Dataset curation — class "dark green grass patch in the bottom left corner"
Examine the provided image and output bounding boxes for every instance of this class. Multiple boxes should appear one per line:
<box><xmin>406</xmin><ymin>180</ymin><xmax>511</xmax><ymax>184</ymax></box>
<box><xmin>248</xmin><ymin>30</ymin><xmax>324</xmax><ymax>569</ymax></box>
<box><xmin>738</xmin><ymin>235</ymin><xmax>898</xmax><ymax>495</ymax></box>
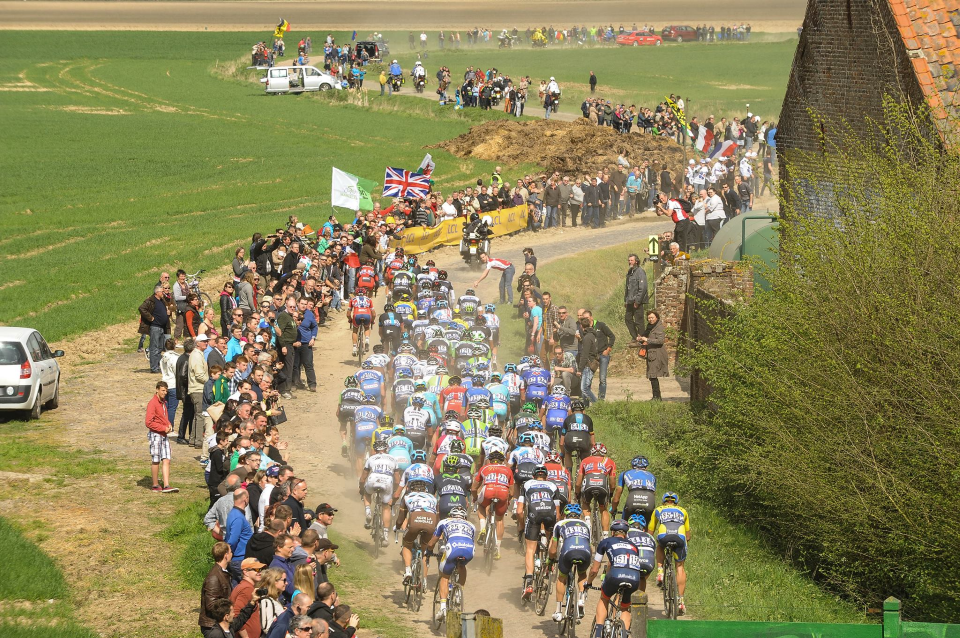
<box><xmin>0</xmin><ymin>517</ymin><xmax>96</xmax><ymax>638</ymax></box>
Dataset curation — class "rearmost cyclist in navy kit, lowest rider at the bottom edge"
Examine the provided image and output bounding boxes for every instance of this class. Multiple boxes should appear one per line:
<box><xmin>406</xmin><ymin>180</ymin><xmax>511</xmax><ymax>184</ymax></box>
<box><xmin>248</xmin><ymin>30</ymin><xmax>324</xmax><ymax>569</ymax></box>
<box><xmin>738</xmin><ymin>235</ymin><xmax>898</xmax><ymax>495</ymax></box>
<box><xmin>587</xmin><ymin>520</ymin><xmax>650</xmax><ymax>638</ymax></box>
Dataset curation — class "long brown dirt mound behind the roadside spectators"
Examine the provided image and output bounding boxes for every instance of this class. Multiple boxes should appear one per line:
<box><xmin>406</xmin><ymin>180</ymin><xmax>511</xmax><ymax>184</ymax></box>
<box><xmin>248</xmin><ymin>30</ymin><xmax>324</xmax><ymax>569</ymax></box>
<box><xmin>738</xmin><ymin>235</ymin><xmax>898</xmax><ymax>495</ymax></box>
<box><xmin>432</xmin><ymin>118</ymin><xmax>684</xmax><ymax>178</ymax></box>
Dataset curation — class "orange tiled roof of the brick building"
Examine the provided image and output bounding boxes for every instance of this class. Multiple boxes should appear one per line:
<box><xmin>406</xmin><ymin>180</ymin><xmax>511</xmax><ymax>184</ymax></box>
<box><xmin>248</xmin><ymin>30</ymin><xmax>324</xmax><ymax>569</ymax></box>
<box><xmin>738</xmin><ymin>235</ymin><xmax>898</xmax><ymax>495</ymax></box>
<box><xmin>887</xmin><ymin>0</ymin><xmax>960</xmax><ymax>134</ymax></box>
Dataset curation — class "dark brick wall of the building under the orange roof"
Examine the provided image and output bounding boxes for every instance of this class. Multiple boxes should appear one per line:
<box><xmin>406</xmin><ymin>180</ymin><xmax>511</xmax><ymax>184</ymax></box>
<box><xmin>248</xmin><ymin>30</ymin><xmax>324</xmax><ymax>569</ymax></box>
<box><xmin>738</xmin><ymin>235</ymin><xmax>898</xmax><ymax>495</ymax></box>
<box><xmin>777</xmin><ymin>0</ymin><xmax>933</xmax><ymax>216</ymax></box>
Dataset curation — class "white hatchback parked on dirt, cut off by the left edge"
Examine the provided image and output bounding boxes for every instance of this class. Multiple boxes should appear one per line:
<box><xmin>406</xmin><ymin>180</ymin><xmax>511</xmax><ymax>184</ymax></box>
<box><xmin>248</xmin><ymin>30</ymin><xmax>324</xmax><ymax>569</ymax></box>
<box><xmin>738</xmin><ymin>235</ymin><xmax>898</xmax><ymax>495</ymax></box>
<box><xmin>0</xmin><ymin>326</ymin><xmax>63</xmax><ymax>419</ymax></box>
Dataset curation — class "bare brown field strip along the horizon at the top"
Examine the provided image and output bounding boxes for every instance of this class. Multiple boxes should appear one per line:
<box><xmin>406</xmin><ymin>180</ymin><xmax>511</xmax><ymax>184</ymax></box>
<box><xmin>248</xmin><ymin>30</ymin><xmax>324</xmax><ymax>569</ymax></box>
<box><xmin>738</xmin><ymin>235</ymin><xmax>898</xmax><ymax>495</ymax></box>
<box><xmin>0</xmin><ymin>0</ymin><xmax>807</xmax><ymax>31</ymax></box>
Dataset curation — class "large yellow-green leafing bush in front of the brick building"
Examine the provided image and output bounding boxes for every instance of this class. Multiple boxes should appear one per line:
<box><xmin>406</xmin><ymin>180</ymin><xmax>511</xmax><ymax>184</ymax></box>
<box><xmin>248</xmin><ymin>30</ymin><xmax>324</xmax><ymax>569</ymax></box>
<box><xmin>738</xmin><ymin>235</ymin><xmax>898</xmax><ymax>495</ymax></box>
<box><xmin>674</xmin><ymin>105</ymin><xmax>960</xmax><ymax>620</ymax></box>
